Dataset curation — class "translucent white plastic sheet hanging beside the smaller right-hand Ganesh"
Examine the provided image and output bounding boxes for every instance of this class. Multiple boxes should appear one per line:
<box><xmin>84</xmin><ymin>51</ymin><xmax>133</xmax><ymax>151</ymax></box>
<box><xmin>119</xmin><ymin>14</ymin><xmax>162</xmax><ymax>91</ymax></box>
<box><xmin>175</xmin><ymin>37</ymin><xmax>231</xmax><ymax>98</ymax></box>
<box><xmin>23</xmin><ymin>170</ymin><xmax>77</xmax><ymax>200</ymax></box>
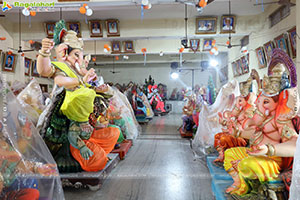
<box><xmin>192</xmin><ymin>80</ymin><xmax>240</xmax><ymax>157</ymax></box>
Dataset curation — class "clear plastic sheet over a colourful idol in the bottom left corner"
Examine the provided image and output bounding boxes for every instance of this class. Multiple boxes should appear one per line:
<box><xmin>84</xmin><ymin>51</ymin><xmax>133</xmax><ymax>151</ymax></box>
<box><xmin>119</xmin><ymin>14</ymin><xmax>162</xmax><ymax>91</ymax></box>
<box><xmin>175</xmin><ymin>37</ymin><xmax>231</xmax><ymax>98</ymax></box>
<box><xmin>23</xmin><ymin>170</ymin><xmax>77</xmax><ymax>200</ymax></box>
<box><xmin>0</xmin><ymin>74</ymin><xmax>64</xmax><ymax>200</ymax></box>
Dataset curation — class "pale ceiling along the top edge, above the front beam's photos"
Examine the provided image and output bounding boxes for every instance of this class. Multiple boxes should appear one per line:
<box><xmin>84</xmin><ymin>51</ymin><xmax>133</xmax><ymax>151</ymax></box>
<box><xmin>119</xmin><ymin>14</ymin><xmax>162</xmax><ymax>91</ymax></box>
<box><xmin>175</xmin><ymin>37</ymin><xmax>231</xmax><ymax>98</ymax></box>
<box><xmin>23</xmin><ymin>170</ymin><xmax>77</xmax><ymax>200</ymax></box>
<box><xmin>0</xmin><ymin>0</ymin><xmax>262</xmax><ymax>22</ymax></box>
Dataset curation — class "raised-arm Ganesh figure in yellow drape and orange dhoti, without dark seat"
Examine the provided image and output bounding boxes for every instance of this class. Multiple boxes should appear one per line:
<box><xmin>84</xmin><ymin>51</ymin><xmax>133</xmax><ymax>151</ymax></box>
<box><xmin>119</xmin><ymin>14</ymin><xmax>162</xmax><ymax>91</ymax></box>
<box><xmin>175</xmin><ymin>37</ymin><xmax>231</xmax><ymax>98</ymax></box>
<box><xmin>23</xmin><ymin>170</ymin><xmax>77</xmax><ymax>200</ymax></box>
<box><xmin>37</xmin><ymin>20</ymin><xmax>120</xmax><ymax>171</ymax></box>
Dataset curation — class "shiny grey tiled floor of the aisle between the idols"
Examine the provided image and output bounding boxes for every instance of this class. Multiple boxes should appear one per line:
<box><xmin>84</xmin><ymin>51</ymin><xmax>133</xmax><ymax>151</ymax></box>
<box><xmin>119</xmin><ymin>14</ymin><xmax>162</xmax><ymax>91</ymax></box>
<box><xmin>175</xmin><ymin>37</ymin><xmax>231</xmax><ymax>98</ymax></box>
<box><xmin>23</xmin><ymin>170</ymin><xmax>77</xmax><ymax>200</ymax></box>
<box><xmin>65</xmin><ymin>115</ymin><xmax>214</xmax><ymax>200</ymax></box>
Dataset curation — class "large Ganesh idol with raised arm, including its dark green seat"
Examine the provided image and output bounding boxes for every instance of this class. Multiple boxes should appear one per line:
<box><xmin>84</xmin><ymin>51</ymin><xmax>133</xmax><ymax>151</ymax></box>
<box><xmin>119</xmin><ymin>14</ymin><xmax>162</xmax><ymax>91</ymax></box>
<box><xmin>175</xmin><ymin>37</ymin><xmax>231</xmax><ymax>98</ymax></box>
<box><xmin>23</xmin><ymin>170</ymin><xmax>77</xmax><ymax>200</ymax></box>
<box><xmin>37</xmin><ymin>20</ymin><xmax>120</xmax><ymax>172</ymax></box>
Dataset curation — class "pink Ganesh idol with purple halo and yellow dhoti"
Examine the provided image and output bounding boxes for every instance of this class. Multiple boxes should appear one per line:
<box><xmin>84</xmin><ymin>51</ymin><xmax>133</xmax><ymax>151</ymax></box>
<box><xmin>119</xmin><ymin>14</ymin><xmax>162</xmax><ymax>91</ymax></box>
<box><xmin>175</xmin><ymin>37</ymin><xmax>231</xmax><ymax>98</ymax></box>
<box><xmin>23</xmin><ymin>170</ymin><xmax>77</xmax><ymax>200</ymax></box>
<box><xmin>224</xmin><ymin>49</ymin><xmax>299</xmax><ymax>195</ymax></box>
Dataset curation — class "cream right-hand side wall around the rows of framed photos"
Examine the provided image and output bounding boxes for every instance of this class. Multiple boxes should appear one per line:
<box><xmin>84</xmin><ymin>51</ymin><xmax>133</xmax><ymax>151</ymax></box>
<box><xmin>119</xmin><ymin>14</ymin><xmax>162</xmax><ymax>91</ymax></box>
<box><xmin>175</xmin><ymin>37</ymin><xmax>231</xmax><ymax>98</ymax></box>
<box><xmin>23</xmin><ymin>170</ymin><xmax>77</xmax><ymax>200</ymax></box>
<box><xmin>228</xmin><ymin>6</ymin><xmax>299</xmax><ymax>82</ymax></box>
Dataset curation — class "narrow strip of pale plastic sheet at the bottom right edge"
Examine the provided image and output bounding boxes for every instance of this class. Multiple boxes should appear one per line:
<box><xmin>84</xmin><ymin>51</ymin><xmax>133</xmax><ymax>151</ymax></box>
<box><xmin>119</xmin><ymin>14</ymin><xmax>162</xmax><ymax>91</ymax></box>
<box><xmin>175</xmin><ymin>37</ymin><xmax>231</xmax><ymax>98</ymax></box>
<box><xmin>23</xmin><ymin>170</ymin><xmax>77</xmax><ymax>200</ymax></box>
<box><xmin>289</xmin><ymin>137</ymin><xmax>300</xmax><ymax>200</ymax></box>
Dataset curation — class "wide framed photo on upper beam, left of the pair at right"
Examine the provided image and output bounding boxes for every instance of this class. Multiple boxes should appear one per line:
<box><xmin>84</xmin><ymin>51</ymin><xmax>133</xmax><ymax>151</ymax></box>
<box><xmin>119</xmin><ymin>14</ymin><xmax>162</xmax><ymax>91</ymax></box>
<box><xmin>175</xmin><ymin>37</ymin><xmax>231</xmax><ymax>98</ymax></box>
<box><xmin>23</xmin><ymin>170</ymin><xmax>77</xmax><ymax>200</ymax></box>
<box><xmin>196</xmin><ymin>17</ymin><xmax>217</xmax><ymax>34</ymax></box>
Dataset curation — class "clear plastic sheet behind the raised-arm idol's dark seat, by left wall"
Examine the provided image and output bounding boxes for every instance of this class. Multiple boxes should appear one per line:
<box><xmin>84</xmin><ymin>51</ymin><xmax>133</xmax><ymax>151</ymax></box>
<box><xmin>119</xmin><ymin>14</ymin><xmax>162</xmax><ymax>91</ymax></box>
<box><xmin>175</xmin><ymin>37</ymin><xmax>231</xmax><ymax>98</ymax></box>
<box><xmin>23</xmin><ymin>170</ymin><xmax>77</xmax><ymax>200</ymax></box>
<box><xmin>17</xmin><ymin>79</ymin><xmax>45</xmax><ymax>125</ymax></box>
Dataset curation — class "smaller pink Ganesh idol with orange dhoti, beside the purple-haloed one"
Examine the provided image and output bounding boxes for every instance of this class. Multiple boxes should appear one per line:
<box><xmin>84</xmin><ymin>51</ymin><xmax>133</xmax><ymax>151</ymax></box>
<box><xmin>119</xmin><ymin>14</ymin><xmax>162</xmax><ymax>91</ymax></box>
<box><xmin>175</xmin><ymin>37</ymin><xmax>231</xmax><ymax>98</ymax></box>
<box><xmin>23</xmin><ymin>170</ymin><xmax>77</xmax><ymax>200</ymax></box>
<box><xmin>214</xmin><ymin>71</ymin><xmax>257</xmax><ymax>163</ymax></box>
